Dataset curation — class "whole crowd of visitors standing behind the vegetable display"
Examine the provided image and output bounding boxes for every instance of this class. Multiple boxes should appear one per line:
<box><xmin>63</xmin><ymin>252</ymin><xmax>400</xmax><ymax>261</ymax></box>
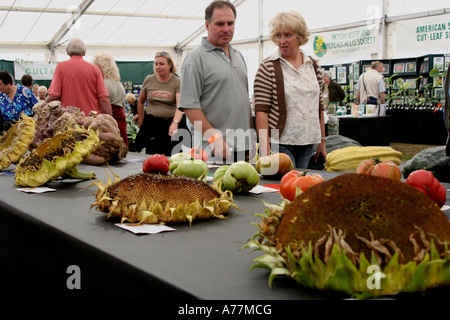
<box><xmin>5</xmin><ymin>0</ymin><xmax>436</xmax><ymax>168</ymax></box>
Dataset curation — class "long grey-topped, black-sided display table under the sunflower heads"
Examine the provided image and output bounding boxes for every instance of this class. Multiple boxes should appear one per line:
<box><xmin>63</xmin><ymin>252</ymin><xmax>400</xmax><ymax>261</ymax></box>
<box><xmin>0</xmin><ymin>153</ymin><xmax>449</xmax><ymax>301</ymax></box>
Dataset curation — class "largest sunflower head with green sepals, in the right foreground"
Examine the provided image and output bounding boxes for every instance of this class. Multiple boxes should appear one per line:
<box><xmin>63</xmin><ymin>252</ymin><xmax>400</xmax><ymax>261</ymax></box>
<box><xmin>245</xmin><ymin>174</ymin><xmax>450</xmax><ymax>298</ymax></box>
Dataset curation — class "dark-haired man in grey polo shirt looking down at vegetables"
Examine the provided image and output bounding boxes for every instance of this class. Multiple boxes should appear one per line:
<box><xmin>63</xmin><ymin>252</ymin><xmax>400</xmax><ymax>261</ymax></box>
<box><xmin>178</xmin><ymin>1</ymin><xmax>251</xmax><ymax>162</ymax></box>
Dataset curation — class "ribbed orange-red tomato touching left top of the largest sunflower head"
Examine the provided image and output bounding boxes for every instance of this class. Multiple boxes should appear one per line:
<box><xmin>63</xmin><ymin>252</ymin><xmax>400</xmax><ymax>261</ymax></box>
<box><xmin>280</xmin><ymin>170</ymin><xmax>325</xmax><ymax>201</ymax></box>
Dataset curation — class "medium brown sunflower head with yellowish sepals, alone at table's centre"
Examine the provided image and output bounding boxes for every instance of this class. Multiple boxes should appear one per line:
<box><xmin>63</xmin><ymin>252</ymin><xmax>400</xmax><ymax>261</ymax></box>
<box><xmin>92</xmin><ymin>172</ymin><xmax>233</xmax><ymax>224</ymax></box>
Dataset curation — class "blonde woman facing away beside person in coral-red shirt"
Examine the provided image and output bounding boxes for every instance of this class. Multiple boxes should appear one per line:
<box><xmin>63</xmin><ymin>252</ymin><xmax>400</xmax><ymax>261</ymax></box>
<box><xmin>92</xmin><ymin>52</ymin><xmax>128</xmax><ymax>147</ymax></box>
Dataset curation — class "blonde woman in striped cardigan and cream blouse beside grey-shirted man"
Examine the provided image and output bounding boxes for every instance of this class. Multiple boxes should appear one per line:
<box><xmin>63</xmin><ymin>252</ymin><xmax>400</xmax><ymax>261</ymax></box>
<box><xmin>254</xmin><ymin>11</ymin><xmax>326</xmax><ymax>168</ymax></box>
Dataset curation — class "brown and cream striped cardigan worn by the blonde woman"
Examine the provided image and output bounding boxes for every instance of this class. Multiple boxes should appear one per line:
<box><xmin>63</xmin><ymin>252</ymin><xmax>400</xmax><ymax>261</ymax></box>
<box><xmin>253</xmin><ymin>57</ymin><xmax>324</xmax><ymax>139</ymax></box>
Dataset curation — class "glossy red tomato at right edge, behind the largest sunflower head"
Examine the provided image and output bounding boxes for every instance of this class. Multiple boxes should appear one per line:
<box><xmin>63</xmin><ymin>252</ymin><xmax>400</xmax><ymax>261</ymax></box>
<box><xmin>405</xmin><ymin>170</ymin><xmax>447</xmax><ymax>207</ymax></box>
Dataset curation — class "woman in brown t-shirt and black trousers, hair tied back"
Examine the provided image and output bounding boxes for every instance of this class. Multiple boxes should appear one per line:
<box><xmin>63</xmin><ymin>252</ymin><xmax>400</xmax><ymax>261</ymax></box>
<box><xmin>136</xmin><ymin>51</ymin><xmax>187</xmax><ymax>156</ymax></box>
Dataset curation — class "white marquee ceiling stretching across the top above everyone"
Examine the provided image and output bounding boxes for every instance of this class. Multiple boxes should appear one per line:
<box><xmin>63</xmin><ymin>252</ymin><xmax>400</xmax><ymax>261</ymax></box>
<box><xmin>0</xmin><ymin>0</ymin><xmax>448</xmax><ymax>55</ymax></box>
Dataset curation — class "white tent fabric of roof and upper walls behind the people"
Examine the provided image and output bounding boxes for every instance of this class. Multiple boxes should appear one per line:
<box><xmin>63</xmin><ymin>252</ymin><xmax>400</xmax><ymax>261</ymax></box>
<box><xmin>0</xmin><ymin>0</ymin><xmax>450</xmax><ymax>93</ymax></box>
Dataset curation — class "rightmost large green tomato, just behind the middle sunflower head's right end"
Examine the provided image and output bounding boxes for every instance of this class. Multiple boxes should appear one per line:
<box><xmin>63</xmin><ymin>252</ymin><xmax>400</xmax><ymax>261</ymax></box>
<box><xmin>223</xmin><ymin>161</ymin><xmax>259</xmax><ymax>193</ymax></box>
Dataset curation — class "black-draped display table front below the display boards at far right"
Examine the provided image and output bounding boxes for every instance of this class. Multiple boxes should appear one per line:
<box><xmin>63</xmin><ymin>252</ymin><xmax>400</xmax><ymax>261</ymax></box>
<box><xmin>386</xmin><ymin>108</ymin><xmax>447</xmax><ymax>145</ymax></box>
